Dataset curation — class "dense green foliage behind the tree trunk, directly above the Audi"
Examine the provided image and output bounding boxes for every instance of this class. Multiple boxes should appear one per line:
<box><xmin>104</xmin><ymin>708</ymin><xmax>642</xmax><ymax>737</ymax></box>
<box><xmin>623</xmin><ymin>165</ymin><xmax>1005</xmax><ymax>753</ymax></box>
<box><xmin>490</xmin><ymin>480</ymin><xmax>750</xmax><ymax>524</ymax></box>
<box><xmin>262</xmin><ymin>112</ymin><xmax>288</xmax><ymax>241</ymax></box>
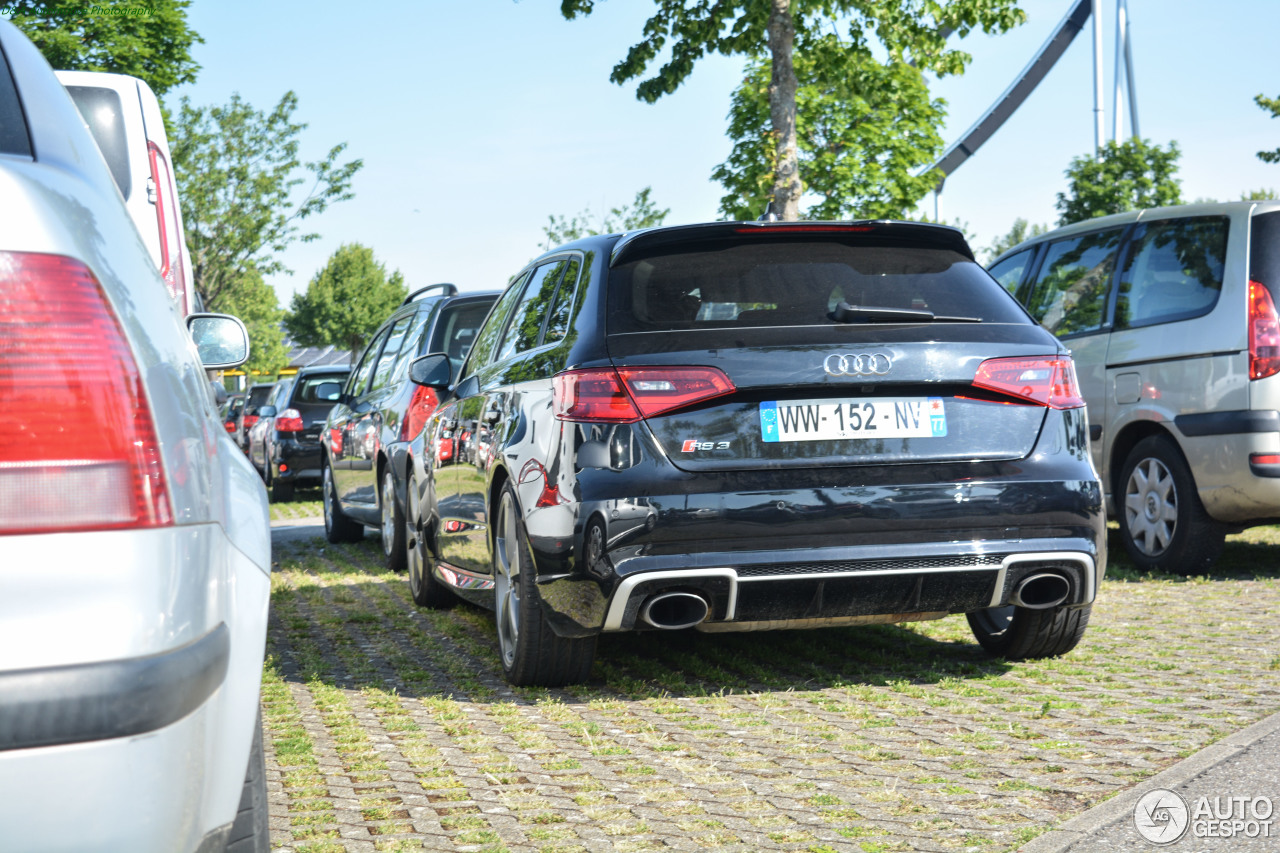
<box><xmin>712</xmin><ymin>43</ymin><xmax>946</xmax><ymax>219</ymax></box>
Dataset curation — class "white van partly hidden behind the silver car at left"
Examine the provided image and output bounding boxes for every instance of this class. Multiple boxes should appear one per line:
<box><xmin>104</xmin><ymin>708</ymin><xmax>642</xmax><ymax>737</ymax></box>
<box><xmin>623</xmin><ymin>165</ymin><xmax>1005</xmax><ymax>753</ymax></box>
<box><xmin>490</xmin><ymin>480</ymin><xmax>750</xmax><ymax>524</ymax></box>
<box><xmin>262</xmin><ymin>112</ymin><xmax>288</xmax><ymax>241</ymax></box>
<box><xmin>56</xmin><ymin>70</ymin><xmax>194</xmax><ymax>315</ymax></box>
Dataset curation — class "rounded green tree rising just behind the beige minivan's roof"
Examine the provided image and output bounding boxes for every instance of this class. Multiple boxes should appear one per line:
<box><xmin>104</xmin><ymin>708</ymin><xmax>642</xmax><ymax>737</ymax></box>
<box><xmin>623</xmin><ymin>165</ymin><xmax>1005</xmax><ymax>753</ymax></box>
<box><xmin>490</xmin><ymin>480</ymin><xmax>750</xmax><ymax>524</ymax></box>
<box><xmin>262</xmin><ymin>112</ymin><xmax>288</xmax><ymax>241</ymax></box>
<box><xmin>1055</xmin><ymin>138</ymin><xmax>1181</xmax><ymax>225</ymax></box>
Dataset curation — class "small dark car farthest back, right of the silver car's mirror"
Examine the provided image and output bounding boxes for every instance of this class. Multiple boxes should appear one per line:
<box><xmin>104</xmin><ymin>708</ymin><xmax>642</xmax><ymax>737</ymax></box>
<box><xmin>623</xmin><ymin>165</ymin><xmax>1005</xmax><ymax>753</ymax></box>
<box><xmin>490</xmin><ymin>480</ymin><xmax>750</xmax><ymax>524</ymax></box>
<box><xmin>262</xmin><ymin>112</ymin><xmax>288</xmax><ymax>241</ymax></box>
<box><xmin>250</xmin><ymin>365</ymin><xmax>351</xmax><ymax>501</ymax></box>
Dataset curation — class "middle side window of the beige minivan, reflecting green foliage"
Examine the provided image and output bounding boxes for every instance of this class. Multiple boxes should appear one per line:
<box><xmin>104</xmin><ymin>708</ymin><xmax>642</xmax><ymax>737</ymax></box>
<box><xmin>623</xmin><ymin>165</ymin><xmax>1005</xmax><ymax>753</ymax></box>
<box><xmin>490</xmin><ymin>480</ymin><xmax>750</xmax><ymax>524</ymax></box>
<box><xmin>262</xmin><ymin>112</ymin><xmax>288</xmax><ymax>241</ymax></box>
<box><xmin>1027</xmin><ymin>228</ymin><xmax>1124</xmax><ymax>336</ymax></box>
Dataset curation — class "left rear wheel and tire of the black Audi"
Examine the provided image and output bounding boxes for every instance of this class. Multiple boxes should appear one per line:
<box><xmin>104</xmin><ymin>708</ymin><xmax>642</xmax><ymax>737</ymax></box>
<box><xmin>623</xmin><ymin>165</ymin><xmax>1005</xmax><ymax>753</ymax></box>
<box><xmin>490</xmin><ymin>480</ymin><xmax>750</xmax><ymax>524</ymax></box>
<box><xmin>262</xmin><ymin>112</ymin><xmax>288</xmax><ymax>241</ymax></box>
<box><xmin>493</xmin><ymin>483</ymin><xmax>595</xmax><ymax>686</ymax></box>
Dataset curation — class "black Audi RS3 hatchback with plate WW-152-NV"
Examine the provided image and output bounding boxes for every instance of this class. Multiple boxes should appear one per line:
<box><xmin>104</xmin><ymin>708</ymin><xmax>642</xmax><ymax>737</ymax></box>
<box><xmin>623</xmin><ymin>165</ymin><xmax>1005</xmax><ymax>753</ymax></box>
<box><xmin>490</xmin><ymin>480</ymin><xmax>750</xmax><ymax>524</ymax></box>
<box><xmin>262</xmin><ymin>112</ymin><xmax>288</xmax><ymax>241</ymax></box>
<box><xmin>404</xmin><ymin>222</ymin><xmax>1106</xmax><ymax>685</ymax></box>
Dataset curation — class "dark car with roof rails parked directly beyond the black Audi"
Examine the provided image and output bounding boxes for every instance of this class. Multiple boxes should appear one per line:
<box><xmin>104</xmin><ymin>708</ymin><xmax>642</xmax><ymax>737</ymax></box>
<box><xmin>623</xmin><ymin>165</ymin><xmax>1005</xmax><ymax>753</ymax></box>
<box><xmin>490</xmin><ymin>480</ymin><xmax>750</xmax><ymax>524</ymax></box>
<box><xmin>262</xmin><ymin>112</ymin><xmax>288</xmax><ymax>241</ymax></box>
<box><xmin>321</xmin><ymin>284</ymin><xmax>498</xmax><ymax>571</ymax></box>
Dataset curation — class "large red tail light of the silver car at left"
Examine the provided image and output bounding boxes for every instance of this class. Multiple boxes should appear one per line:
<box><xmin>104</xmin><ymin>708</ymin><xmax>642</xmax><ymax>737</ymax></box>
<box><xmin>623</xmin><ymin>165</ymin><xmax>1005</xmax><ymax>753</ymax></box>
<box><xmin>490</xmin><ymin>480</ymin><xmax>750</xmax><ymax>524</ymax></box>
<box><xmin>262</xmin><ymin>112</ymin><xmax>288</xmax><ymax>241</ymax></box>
<box><xmin>0</xmin><ymin>252</ymin><xmax>173</xmax><ymax>533</ymax></box>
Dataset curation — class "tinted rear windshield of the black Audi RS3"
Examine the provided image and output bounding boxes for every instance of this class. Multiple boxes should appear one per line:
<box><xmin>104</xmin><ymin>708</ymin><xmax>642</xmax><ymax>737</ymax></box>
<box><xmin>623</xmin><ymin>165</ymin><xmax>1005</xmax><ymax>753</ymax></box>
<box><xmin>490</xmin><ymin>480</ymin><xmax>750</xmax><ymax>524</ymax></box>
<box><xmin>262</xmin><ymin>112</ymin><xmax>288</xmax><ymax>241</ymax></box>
<box><xmin>609</xmin><ymin>240</ymin><xmax>1029</xmax><ymax>334</ymax></box>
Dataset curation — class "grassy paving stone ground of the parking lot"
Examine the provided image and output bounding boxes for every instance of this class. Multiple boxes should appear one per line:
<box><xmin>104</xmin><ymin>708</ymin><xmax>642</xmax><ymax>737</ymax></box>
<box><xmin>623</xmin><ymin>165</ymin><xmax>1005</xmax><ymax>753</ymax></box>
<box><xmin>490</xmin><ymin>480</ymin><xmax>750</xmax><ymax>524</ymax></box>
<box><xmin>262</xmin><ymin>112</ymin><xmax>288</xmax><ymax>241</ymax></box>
<box><xmin>262</xmin><ymin>538</ymin><xmax>1280</xmax><ymax>853</ymax></box>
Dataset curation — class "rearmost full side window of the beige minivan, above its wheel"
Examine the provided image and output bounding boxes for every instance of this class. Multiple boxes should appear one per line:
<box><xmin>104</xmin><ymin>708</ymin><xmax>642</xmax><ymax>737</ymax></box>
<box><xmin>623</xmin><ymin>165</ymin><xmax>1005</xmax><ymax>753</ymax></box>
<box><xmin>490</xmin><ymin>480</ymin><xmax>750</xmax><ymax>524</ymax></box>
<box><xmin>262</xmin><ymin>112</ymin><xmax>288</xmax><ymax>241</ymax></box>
<box><xmin>1116</xmin><ymin>216</ymin><xmax>1231</xmax><ymax>328</ymax></box>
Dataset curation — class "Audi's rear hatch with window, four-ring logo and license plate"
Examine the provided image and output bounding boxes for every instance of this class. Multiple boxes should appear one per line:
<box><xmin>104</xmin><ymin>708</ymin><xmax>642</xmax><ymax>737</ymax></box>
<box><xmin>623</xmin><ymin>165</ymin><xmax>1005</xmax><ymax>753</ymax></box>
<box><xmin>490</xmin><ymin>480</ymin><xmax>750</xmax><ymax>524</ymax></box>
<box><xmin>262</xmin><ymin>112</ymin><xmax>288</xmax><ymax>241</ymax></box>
<box><xmin>607</xmin><ymin>223</ymin><xmax>1062</xmax><ymax>471</ymax></box>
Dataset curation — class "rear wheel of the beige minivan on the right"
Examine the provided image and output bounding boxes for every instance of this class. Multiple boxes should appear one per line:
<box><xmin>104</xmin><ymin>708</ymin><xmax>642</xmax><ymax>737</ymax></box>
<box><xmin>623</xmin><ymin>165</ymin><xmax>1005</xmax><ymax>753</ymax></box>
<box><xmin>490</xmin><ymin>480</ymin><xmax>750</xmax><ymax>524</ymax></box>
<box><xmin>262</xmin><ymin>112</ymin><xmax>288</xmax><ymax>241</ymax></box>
<box><xmin>1116</xmin><ymin>435</ymin><xmax>1226</xmax><ymax>575</ymax></box>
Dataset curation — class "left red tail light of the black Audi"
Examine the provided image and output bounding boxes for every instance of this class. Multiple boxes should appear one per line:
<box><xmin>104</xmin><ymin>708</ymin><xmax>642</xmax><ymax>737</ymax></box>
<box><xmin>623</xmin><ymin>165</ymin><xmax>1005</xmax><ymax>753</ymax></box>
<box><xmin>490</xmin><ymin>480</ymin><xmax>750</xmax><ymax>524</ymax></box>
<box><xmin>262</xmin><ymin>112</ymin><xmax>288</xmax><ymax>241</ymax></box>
<box><xmin>553</xmin><ymin>368</ymin><xmax>736</xmax><ymax>424</ymax></box>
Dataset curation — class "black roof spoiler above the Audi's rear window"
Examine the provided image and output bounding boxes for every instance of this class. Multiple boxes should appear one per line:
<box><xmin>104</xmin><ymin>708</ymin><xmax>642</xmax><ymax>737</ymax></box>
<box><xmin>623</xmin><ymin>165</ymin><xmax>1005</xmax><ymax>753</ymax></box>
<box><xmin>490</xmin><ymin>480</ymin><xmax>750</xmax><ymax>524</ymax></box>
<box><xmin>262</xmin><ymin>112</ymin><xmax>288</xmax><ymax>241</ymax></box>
<box><xmin>609</xmin><ymin>219</ymin><xmax>975</xmax><ymax>266</ymax></box>
